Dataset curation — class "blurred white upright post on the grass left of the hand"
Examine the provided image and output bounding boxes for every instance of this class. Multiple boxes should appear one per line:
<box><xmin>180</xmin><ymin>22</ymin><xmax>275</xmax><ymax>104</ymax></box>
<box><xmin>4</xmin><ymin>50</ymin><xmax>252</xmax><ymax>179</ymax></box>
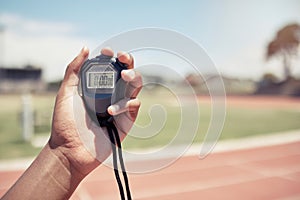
<box><xmin>21</xmin><ymin>94</ymin><xmax>33</xmax><ymax>142</ymax></box>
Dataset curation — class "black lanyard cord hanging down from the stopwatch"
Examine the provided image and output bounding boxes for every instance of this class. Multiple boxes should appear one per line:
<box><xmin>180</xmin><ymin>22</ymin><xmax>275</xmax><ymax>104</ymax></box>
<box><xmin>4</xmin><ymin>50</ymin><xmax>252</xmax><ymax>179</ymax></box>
<box><xmin>100</xmin><ymin>121</ymin><xmax>131</xmax><ymax>200</ymax></box>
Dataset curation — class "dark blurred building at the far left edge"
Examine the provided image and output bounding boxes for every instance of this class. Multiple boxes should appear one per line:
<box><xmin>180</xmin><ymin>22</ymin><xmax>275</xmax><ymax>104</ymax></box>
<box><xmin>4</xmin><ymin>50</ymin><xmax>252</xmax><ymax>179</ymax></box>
<box><xmin>0</xmin><ymin>66</ymin><xmax>46</xmax><ymax>93</ymax></box>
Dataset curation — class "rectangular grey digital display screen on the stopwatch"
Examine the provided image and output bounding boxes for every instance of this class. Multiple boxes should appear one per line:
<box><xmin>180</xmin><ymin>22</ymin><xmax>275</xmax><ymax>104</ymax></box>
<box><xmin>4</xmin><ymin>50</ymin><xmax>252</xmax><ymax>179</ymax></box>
<box><xmin>87</xmin><ymin>71</ymin><xmax>115</xmax><ymax>89</ymax></box>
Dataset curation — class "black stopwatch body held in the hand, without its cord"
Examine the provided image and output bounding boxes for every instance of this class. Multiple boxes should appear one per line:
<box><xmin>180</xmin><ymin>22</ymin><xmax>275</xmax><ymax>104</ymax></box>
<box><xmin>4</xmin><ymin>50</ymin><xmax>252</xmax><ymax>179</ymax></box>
<box><xmin>79</xmin><ymin>55</ymin><xmax>127</xmax><ymax>123</ymax></box>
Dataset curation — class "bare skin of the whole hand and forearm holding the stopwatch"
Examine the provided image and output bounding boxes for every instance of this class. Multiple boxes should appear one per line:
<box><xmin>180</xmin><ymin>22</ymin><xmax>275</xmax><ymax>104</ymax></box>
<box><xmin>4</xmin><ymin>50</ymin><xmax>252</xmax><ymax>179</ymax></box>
<box><xmin>2</xmin><ymin>47</ymin><xmax>142</xmax><ymax>200</ymax></box>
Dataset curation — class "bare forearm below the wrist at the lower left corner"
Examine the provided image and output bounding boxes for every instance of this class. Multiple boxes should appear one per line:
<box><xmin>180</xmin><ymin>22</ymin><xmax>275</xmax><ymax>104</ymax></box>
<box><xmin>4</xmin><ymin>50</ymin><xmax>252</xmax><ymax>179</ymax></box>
<box><xmin>2</xmin><ymin>144</ymin><xmax>84</xmax><ymax>200</ymax></box>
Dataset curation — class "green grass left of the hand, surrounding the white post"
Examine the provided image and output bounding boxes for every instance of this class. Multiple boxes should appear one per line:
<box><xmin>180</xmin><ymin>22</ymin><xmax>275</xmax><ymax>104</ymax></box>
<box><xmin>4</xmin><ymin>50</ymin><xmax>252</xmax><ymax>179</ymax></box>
<box><xmin>0</xmin><ymin>95</ymin><xmax>55</xmax><ymax>159</ymax></box>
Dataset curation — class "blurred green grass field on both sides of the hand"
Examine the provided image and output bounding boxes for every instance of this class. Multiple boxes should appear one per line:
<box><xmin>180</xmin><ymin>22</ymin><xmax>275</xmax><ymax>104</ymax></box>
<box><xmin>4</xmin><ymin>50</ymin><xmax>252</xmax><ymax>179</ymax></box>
<box><xmin>0</xmin><ymin>89</ymin><xmax>300</xmax><ymax>159</ymax></box>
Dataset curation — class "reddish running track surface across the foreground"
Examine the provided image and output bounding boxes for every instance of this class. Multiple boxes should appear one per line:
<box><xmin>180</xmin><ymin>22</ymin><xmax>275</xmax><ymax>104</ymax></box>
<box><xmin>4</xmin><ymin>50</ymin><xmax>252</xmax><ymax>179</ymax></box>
<box><xmin>0</xmin><ymin>142</ymin><xmax>300</xmax><ymax>200</ymax></box>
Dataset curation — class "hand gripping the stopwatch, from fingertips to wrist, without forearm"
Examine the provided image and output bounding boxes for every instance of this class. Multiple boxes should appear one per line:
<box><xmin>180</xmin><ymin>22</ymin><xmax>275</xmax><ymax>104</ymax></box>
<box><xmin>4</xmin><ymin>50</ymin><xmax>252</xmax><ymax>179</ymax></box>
<box><xmin>49</xmin><ymin>48</ymin><xmax>142</xmax><ymax>174</ymax></box>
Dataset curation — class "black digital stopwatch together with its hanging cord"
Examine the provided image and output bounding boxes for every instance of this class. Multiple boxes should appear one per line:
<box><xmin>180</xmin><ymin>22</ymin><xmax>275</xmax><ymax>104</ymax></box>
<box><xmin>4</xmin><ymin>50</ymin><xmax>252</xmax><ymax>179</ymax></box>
<box><xmin>78</xmin><ymin>55</ymin><xmax>131</xmax><ymax>200</ymax></box>
